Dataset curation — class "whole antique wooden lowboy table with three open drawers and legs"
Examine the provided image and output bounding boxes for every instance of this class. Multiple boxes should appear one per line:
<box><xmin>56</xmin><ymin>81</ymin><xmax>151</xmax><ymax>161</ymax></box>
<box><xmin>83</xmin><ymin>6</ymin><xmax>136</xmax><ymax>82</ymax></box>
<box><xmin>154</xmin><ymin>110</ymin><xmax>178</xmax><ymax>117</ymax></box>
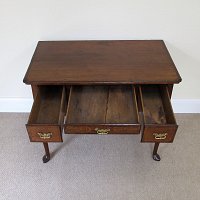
<box><xmin>24</xmin><ymin>40</ymin><xmax>181</xmax><ymax>162</ymax></box>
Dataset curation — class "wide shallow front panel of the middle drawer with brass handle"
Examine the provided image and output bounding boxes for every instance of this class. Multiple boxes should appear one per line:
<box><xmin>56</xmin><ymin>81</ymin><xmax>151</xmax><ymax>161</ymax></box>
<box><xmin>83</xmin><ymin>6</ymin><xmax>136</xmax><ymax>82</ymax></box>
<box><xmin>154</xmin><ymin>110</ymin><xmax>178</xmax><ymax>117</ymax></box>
<box><xmin>65</xmin><ymin>124</ymin><xmax>140</xmax><ymax>135</ymax></box>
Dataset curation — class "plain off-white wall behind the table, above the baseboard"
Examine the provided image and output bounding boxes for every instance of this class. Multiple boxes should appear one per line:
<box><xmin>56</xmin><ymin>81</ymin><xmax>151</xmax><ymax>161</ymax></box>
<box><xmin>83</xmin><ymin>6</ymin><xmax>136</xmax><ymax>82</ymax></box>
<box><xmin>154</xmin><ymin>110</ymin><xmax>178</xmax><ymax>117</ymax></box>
<box><xmin>0</xmin><ymin>0</ymin><xmax>200</xmax><ymax>111</ymax></box>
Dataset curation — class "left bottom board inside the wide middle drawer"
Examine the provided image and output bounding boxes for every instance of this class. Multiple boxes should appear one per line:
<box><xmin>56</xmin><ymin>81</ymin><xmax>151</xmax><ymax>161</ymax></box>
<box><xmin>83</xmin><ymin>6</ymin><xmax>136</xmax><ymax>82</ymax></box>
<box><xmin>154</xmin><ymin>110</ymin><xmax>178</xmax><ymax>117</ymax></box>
<box><xmin>67</xmin><ymin>86</ymin><xmax>108</xmax><ymax>124</ymax></box>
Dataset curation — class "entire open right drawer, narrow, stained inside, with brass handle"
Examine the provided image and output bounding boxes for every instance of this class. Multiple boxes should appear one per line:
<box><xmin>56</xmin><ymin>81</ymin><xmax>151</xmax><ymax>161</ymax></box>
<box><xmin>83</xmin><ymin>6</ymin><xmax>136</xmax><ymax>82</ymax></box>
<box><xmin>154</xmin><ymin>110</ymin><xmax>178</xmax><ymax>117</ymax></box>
<box><xmin>139</xmin><ymin>85</ymin><xmax>178</xmax><ymax>142</ymax></box>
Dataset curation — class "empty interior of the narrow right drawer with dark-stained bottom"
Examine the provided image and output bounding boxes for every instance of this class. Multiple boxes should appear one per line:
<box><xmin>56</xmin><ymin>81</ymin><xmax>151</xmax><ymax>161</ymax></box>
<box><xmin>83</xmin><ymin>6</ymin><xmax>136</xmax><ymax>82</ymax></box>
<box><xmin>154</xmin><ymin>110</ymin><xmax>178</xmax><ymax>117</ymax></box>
<box><xmin>140</xmin><ymin>85</ymin><xmax>176</xmax><ymax>125</ymax></box>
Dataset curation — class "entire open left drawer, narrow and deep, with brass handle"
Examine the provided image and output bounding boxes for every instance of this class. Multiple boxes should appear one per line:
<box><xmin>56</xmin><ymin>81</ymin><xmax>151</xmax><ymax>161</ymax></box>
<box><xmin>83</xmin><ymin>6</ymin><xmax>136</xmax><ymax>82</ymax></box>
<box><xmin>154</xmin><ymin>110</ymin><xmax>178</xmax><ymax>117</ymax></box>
<box><xmin>26</xmin><ymin>86</ymin><xmax>66</xmax><ymax>142</ymax></box>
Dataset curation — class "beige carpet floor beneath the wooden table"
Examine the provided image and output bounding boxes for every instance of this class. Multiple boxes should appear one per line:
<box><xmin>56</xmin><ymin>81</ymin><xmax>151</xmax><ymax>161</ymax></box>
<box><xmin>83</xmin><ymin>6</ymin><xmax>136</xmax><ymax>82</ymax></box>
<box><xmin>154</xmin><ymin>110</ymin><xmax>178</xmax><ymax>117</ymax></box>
<box><xmin>0</xmin><ymin>113</ymin><xmax>200</xmax><ymax>200</ymax></box>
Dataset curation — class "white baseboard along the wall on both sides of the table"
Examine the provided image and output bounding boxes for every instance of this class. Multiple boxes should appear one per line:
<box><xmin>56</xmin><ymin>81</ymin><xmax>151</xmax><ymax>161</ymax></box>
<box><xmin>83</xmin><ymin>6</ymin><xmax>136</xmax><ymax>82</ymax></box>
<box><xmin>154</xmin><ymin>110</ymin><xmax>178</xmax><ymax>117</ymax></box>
<box><xmin>0</xmin><ymin>98</ymin><xmax>200</xmax><ymax>113</ymax></box>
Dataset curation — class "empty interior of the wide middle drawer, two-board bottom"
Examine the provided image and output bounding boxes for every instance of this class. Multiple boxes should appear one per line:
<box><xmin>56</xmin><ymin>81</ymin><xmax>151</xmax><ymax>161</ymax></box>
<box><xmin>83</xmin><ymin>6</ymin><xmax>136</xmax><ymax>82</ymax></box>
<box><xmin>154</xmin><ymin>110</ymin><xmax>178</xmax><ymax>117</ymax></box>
<box><xmin>66</xmin><ymin>85</ymin><xmax>138</xmax><ymax>124</ymax></box>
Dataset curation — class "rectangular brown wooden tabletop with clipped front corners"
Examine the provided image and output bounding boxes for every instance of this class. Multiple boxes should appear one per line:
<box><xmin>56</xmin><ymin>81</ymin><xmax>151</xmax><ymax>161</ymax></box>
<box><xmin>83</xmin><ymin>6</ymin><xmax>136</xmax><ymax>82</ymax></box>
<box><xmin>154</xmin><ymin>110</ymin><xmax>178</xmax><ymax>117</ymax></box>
<box><xmin>24</xmin><ymin>40</ymin><xmax>181</xmax><ymax>85</ymax></box>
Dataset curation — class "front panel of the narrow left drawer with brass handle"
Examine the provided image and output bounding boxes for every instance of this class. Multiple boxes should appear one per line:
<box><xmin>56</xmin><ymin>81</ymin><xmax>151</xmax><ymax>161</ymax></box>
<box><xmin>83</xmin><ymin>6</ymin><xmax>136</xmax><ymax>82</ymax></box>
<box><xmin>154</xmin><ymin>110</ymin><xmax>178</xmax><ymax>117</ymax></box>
<box><xmin>26</xmin><ymin>125</ymin><xmax>62</xmax><ymax>142</ymax></box>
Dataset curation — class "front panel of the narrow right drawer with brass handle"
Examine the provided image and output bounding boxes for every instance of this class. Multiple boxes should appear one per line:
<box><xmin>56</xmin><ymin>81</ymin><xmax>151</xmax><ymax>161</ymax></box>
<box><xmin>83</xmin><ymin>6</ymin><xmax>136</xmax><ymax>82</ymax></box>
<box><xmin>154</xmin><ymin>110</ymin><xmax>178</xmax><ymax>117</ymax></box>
<box><xmin>142</xmin><ymin>125</ymin><xmax>178</xmax><ymax>143</ymax></box>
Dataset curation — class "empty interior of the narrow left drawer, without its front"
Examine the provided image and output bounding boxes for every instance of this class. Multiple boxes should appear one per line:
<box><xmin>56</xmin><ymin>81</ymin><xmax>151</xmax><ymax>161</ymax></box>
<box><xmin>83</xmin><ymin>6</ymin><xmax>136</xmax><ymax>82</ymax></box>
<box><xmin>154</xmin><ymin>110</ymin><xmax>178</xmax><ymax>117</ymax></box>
<box><xmin>28</xmin><ymin>86</ymin><xmax>64</xmax><ymax>124</ymax></box>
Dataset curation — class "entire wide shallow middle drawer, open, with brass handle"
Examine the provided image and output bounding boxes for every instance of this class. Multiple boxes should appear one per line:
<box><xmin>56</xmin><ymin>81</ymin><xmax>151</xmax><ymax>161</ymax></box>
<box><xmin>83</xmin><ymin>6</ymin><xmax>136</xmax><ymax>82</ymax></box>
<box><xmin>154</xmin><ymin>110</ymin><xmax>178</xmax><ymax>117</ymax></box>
<box><xmin>64</xmin><ymin>85</ymin><xmax>140</xmax><ymax>134</ymax></box>
